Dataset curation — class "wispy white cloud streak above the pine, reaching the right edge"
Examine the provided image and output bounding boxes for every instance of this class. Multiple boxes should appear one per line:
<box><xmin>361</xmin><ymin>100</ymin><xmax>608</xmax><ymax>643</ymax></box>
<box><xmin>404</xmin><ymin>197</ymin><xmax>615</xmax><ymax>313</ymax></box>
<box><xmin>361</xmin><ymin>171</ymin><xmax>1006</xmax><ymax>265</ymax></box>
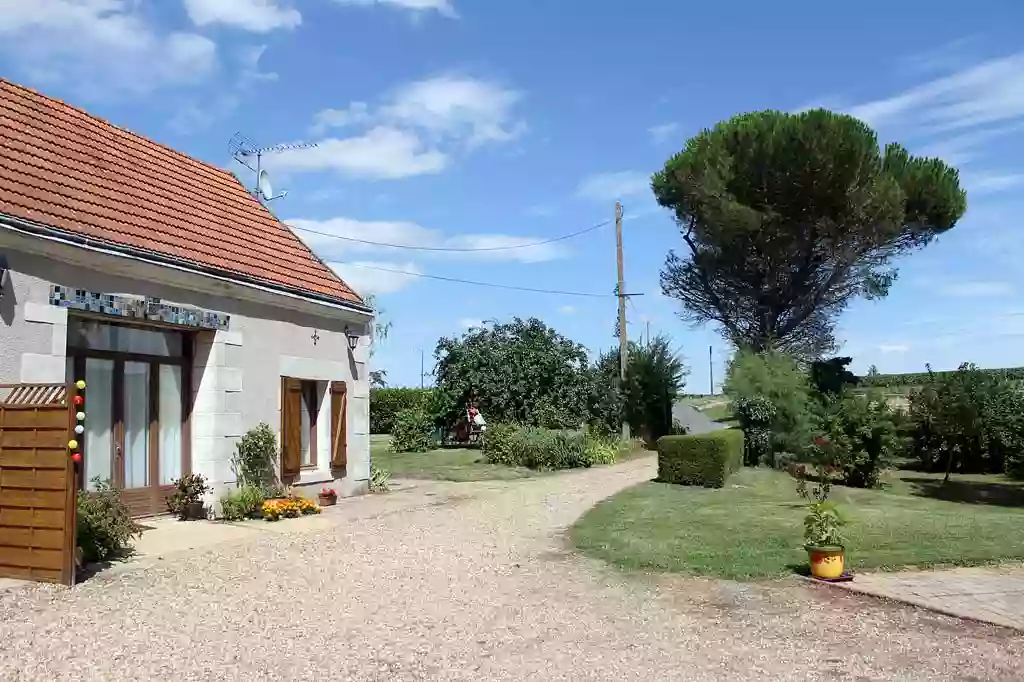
<box><xmin>849</xmin><ymin>52</ymin><xmax>1024</xmax><ymax>131</ymax></box>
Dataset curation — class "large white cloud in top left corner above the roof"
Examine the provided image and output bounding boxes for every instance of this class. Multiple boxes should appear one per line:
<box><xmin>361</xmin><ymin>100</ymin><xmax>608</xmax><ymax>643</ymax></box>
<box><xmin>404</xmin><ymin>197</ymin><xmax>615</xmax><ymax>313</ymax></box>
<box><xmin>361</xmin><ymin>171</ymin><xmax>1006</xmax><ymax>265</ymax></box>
<box><xmin>0</xmin><ymin>0</ymin><xmax>217</xmax><ymax>94</ymax></box>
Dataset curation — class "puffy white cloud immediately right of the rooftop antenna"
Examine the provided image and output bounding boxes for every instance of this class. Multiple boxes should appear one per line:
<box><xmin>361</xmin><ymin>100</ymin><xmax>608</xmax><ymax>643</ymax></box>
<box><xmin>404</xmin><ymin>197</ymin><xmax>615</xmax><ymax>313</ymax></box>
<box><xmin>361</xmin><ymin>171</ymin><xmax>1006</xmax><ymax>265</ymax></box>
<box><xmin>267</xmin><ymin>126</ymin><xmax>447</xmax><ymax>179</ymax></box>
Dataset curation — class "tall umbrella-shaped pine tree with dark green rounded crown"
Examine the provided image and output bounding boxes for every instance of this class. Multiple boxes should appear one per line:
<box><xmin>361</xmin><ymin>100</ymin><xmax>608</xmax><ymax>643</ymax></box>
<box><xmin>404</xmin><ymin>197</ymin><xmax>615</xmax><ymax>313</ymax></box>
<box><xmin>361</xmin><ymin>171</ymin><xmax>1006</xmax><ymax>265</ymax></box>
<box><xmin>652</xmin><ymin>110</ymin><xmax>967</xmax><ymax>358</ymax></box>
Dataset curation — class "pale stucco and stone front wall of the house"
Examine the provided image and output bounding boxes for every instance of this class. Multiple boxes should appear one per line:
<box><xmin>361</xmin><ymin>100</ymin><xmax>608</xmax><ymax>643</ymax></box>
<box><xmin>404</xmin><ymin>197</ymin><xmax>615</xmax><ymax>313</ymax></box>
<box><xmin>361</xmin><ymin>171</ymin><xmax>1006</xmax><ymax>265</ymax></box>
<box><xmin>0</xmin><ymin>233</ymin><xmax>370</xmax><ymax>497</ymax></box>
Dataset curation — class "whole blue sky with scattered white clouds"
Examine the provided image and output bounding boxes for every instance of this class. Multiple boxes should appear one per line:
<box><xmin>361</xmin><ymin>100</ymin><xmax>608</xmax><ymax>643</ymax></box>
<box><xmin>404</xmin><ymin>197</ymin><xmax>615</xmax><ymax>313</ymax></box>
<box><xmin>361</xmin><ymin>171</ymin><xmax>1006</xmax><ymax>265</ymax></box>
<box><xmin>0</xmin><ymin>0</ymin><xmax>1024</xmax><ymax>392</ymax></box>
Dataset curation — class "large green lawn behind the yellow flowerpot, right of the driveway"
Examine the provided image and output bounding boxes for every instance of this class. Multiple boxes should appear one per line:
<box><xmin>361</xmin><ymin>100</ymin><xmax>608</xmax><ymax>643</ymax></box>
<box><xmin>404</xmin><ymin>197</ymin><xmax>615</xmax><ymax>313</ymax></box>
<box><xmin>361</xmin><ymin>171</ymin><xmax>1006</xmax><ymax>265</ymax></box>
<box><xmin>571</xmin><ymin>462</ymin><xmax>1024</xmax><ymax>580</ymax></box>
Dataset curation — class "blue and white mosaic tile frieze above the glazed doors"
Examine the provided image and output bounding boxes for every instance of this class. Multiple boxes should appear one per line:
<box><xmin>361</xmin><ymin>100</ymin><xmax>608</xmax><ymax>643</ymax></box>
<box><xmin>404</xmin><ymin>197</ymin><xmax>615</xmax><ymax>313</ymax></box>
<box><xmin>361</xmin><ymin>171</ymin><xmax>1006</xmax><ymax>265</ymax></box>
<box><xmin>50</xmin><ymin>285</ymin><xmax>230</xmax><ymax>331</ymax></box>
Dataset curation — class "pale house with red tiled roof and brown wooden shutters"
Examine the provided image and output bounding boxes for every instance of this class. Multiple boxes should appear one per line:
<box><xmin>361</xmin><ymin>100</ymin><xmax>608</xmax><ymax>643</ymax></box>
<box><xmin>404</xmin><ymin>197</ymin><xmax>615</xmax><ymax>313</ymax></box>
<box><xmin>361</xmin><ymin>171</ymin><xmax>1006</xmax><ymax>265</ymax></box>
<box><xmin>0</xmin><ymin>80</ymin><xmax>374</xmax><ymax>515</ymax></box>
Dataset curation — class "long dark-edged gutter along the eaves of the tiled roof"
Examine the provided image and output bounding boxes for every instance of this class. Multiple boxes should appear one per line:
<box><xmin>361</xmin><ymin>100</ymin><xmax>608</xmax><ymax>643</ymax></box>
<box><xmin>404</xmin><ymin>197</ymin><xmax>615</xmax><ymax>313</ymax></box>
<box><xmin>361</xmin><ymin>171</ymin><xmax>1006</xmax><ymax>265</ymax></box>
<box><xmin>0</xmin><ymin>213</ymin><xmax>374</xmax><ymax>315</ymax></box>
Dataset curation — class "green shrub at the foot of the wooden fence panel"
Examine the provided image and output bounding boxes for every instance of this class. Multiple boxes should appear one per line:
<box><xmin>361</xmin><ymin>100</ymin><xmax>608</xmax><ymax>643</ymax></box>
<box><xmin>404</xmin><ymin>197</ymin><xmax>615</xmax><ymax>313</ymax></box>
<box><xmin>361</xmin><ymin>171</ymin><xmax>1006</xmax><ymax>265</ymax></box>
<box><xmin>75</xmin><ymin>477</ymin><xmax>142</xmax><ymax>562</ymax></box>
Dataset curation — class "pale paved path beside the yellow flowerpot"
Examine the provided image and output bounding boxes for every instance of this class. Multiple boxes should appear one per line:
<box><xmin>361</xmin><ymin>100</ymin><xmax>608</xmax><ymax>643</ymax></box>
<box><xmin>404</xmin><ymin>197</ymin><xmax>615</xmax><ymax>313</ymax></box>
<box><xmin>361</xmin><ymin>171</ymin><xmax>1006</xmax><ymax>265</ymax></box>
<box><xmin>839</xmin><ymin>564</ymin><xmax>1024</xmax><ymax>631</ymax></box>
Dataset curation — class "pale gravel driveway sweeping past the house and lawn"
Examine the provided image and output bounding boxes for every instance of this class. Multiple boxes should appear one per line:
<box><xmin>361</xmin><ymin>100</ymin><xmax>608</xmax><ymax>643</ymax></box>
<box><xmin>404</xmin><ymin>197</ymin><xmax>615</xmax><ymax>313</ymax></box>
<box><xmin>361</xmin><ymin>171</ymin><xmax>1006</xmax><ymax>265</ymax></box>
<box><xmin>0</xmin><ymin>459</ymin><xmax>1024</xmax><ymax>682</ymax></box>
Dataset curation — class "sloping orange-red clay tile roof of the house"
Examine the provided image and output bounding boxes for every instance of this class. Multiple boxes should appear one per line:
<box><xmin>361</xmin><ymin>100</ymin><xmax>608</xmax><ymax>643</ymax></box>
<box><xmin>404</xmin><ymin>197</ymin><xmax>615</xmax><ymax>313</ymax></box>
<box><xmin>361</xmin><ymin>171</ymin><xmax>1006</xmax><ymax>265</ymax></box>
<box><xmin>0</xmin><ymin>79</ymin><xmax>362</xmax><ymax>304</ymax></box>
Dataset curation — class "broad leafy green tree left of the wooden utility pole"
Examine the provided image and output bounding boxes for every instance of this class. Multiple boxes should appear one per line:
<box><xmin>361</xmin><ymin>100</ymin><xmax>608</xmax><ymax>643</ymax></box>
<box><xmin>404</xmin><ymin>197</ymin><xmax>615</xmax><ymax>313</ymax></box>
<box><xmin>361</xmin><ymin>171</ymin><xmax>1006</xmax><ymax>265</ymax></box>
<box><xmin>434</xmin><ymin>317</ymin><xmax>593</xmax><ymax>428</ymax></box>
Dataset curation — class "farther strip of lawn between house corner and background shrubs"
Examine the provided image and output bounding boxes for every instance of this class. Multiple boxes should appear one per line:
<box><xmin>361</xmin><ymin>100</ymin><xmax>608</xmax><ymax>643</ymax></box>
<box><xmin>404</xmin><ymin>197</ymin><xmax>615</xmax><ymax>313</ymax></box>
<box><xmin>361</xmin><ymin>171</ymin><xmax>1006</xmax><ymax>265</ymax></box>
<box><xmin>370</xmin><ymin>435</ymin><xmax>652</xmax><ymax>482</ymax></box>
